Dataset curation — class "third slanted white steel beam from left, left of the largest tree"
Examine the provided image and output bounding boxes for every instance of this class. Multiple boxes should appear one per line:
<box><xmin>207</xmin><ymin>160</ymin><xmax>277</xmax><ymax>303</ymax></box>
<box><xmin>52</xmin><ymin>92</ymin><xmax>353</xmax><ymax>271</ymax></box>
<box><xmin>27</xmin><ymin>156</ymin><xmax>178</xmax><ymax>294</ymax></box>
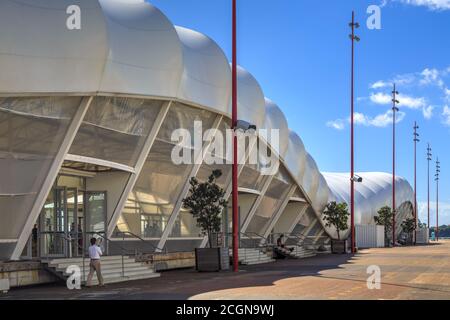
<box><xmin>156</xmin><ymin>115</ymin><xmax>223</xmax><ymax>252</ymax></box>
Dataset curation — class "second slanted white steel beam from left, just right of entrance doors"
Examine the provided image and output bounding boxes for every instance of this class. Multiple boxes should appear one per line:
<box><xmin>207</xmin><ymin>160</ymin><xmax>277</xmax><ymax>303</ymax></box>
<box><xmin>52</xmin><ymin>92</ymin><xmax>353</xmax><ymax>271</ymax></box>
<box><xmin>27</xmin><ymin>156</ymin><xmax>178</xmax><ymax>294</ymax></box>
<box><xmin>107</xmin><ymin>101</ymin><xmax>172</xmax><ymax>238</ymax></box>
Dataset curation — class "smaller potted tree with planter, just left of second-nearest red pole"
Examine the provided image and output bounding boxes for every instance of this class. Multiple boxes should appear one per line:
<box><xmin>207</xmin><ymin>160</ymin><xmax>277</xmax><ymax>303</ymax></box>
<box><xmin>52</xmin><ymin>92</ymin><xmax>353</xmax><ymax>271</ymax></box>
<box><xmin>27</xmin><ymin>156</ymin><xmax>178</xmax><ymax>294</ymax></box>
<box><xmin>323</xmin><ymin>201</ymin><xmax>350</xmax><ymax>253</ymax></box>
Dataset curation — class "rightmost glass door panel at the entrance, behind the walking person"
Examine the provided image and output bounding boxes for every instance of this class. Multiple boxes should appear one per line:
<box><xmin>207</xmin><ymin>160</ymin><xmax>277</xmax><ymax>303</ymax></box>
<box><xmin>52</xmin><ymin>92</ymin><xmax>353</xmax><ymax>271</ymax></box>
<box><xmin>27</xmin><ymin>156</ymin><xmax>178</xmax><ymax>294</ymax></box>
<box><xmin>85</xmin><ymin>191</ymin><xmax>108</xmax><ymax>254</ymax></box>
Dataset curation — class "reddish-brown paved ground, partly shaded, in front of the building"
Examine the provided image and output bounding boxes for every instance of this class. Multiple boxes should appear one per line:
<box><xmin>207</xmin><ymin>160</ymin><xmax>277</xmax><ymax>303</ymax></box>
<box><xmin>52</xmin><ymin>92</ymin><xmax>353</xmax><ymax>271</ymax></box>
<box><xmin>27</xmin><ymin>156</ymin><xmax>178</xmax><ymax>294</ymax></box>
<box><xmin>0</xmin><ymin>240</ymin><xmax>450</xmax><ymax>300</ymax></box>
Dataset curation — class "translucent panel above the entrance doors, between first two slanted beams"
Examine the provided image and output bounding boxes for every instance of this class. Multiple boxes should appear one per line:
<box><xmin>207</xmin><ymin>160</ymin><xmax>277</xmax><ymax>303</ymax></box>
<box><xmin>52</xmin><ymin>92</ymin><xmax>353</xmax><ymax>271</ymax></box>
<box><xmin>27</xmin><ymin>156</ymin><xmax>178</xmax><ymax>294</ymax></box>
<box><xmin>69</xmin><ymin>97</ymin><xmax>164</xmax><ymax>167</ymax></box>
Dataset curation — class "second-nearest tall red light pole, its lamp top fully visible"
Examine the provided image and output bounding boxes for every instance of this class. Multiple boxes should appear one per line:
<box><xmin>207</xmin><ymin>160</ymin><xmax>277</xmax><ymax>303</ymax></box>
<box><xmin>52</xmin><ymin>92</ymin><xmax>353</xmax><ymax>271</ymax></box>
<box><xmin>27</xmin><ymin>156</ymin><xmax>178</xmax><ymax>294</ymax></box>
<box><xmin>349</xmin><ymin>11</ymin><xmax>360</xmax><ymax>253</ymax></box>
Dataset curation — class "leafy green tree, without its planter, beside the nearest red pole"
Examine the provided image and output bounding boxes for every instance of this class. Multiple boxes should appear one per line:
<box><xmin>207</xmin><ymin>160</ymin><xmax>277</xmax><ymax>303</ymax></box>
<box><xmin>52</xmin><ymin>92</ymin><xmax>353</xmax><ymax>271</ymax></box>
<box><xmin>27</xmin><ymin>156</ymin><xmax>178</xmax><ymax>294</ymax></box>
<box><xmin>183</xmin><ymin>170</ymin><xmax>228</xmax><ymax>248</ymax></box>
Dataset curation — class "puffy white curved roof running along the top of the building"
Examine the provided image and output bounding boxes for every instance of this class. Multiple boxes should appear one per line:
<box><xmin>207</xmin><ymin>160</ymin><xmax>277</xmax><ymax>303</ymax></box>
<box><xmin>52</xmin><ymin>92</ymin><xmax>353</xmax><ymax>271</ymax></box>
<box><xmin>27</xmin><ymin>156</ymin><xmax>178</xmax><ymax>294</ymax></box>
<box><xmin>0</xmin><ymin>0</ymin><xmax>411</xmax><ymax>242</ymax></box>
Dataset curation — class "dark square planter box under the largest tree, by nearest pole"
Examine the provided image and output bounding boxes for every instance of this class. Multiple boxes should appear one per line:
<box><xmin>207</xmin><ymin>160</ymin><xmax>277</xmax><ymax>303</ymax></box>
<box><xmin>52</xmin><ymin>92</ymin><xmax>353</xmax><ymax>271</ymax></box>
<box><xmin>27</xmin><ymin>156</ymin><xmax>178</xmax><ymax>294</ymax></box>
<box><xmin>195</xmin><ymin>248</ymin><xmax>230</xmax><ymax>272</ymax></box>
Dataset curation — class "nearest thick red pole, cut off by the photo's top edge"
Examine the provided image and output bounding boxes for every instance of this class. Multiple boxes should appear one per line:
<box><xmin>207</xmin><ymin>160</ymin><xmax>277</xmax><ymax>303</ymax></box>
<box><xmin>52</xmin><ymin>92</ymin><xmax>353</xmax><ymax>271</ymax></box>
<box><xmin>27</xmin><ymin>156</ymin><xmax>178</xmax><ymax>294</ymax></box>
<box><xmin>231</xmin><ymin>0</ymin><xmax>240</xmax><ymax>272</ymax></box>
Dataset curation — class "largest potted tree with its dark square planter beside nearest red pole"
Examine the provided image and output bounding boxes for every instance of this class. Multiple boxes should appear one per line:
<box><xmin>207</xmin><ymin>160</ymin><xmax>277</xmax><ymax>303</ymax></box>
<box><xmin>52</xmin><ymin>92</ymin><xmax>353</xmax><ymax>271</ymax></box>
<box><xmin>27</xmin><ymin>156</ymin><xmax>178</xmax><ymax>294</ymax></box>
<box><xmin>183</xmin><ymin>170</ymin><xmax>230</xmax><ymax>271</ymax></box>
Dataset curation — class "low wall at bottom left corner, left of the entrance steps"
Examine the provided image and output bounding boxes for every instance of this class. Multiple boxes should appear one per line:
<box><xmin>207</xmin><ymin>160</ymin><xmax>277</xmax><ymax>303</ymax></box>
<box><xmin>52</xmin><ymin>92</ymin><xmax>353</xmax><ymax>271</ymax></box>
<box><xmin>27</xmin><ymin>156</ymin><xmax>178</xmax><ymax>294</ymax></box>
<box><xmin>0</xmin><ymin>261</ymin><xmax>58</xmax><ymax>288</ymax></box>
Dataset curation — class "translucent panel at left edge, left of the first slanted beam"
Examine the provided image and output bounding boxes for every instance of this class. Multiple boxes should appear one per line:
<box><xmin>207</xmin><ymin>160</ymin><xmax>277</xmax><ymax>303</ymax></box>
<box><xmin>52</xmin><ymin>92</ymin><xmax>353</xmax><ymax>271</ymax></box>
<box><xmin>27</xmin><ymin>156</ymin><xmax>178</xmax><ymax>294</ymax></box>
<box><xmin>0</xmin><ymin>97</ymin><xmax>82</xmax><ymax>239</ymax></box>
